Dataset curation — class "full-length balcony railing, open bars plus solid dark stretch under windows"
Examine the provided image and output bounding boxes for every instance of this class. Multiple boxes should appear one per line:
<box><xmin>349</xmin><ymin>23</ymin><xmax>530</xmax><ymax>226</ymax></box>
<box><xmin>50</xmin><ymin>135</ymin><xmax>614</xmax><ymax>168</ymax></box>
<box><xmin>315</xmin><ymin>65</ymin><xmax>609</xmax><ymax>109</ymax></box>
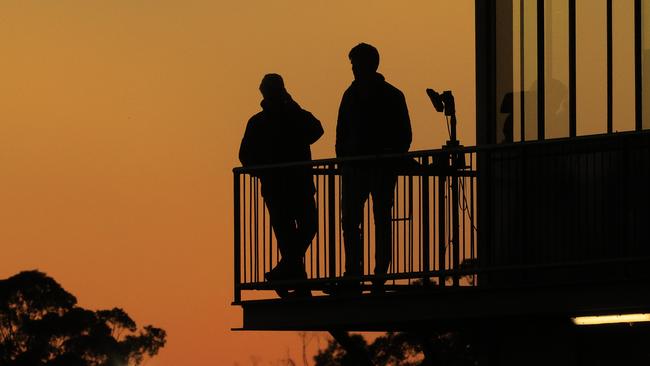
<box><xmin>234</xmin><ymin>131</ymin><xmax>650</xmax><ymax>301</ymax></box>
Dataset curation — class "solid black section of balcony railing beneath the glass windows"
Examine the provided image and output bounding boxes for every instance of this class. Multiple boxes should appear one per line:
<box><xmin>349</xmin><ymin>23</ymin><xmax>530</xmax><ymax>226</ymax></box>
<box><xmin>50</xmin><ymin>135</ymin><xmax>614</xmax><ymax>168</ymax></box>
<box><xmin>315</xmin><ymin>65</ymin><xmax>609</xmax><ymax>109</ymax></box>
<box><xmin>478</xmin><ymin>131</ymin><xmax>650</xmax><ymax>286</ymax></box>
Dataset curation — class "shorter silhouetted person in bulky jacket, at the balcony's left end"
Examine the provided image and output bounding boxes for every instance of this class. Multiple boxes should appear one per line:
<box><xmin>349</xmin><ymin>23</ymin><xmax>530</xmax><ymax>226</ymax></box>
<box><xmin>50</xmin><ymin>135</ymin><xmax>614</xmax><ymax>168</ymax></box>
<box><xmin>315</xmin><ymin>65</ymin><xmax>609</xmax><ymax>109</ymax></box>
<box><xmin>239</xmin><ymin>74</ymin><xmax>323</xmax><ymax>298</ymax></box>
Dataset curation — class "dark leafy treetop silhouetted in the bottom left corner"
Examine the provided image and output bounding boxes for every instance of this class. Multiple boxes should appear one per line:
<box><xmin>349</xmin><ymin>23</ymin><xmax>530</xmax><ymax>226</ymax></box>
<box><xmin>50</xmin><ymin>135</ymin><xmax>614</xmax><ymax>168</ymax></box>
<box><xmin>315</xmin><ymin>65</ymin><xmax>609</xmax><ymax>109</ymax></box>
<box><xmin>0</xmin><ymin>271</ymin><xmax>166</xmax><ymax>366</ymax></box>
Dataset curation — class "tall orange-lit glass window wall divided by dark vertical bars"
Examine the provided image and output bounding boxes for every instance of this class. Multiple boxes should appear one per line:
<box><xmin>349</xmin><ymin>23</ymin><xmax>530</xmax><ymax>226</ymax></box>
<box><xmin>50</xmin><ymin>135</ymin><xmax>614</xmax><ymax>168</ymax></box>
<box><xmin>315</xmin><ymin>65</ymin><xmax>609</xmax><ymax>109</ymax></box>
<box><xmin>494</xmin><ymin>0</ymin><xmax>650</xmax><ymax>142</ymax></box>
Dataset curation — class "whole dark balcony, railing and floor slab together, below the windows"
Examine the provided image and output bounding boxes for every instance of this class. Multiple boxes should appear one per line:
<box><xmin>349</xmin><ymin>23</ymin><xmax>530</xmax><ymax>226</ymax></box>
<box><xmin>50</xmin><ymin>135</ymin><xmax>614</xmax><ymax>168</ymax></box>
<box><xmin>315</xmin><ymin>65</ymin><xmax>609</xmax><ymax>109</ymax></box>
<box><xmin>234</xmin><ymin>132</ymin><xmax>650</xmax><ymax>331</ymax></box>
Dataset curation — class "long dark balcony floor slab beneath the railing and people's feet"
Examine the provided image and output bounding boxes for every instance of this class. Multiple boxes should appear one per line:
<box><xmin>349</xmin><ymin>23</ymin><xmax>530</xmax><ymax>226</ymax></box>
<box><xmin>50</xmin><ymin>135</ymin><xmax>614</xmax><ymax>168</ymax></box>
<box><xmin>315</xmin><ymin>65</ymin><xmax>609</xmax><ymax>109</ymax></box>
<box><xmin>234</xmin><ymin>280</ymin><xmax>650</xmax><ymax>331</ymax></box>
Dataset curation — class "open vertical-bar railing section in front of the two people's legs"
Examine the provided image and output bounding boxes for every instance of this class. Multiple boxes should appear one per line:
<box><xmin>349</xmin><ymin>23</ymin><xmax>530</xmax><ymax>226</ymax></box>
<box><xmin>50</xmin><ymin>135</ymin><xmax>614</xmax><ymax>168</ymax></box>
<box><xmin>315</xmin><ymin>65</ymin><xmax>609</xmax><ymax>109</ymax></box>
<box><xmin>233</xmin><ymin>148</ymin><xmax>477</xmax><ymax>301</ymax></box>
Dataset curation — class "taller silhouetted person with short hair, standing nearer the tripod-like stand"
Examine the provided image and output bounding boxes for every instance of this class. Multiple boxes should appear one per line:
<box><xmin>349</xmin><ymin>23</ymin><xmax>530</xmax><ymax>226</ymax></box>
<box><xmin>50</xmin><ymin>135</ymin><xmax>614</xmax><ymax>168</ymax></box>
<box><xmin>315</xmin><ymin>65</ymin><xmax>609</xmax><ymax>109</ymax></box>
<box><xmin>336</xmin><ymin>43</ymin><xmax>411</xmax><ymax>290</ymax></box>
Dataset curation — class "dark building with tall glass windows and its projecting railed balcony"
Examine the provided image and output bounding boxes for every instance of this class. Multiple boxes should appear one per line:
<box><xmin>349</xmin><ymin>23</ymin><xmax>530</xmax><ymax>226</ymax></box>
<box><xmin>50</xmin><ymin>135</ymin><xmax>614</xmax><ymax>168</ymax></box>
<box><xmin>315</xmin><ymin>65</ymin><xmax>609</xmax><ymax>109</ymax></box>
<box><xmin>234</xmin><ymin>0</ymin><xmax>650</xmax><ymax>365</ymax></box>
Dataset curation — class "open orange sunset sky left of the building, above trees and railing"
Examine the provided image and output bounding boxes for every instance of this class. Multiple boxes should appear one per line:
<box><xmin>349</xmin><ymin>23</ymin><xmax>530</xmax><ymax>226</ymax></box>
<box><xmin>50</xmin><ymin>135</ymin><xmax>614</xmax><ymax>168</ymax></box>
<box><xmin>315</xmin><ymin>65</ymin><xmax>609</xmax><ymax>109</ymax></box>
<box><xmin>0</xmin><ymin>0</ymin><xmax>475</xmax><ymax>366</ymax></box>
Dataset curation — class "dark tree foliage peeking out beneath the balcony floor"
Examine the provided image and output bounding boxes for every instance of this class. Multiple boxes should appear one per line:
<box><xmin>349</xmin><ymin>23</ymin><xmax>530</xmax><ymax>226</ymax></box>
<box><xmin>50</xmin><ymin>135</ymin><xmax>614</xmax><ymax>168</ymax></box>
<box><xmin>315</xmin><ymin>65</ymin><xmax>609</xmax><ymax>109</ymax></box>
<box><xmin>314</xmin><ymin>332</ymin><xmax>477</xmax><ymax>366</ymax></box>
